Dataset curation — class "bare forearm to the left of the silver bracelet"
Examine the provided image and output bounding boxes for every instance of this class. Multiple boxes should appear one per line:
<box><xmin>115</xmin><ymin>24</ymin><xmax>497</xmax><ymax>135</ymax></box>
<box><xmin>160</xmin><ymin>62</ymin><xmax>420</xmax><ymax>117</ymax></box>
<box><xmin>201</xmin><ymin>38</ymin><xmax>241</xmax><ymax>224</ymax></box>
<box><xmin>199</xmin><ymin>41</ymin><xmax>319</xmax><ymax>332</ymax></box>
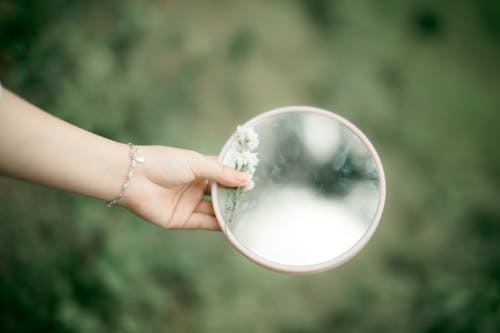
<box><xmin>0</xmin><ymin>89</ymin><xmax>130</xmax><ymax>200</ymax></box>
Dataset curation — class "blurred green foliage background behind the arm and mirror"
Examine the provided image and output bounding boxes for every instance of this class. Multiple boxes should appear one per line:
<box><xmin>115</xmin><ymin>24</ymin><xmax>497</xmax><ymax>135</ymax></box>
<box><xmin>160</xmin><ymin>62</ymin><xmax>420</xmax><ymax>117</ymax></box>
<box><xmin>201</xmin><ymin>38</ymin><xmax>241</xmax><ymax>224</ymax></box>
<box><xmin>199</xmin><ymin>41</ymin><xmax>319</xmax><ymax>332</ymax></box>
<box><xmin>0</xmin><ymin>0</ymin><xmax>500</xmax><ymax>333</ymax></box>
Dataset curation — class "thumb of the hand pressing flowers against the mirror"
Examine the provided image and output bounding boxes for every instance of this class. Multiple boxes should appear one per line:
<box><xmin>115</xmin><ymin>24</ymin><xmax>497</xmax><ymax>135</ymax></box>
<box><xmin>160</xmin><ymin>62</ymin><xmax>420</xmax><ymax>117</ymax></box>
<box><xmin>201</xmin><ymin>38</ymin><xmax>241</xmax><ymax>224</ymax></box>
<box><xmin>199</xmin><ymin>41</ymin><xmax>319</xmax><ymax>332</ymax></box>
<box><xmin>191</xmin><ymin>154</ymin><xmax>250</xmax><ymax>187</ymax></box>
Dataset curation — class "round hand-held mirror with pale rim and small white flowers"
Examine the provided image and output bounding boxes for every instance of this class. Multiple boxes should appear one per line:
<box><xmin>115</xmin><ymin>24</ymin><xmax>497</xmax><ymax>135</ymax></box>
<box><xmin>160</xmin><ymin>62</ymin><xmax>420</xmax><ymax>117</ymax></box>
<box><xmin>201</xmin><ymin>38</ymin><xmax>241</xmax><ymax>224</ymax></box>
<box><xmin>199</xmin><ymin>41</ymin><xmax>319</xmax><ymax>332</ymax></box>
<box><xmin>212</xmin><ymin>106</ymin><xmax>385</xmax><ymax>273</ymax></box>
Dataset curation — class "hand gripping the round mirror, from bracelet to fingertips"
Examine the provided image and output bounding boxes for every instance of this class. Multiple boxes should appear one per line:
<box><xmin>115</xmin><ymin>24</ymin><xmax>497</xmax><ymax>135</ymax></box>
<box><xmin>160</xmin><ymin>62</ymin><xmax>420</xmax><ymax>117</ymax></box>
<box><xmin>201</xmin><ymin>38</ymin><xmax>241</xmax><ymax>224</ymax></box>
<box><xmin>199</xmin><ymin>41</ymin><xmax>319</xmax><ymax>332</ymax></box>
<box><xmin>120</xmin><ymin>146</ymin><xmax>249</xmax><ymax>230</ymax></box>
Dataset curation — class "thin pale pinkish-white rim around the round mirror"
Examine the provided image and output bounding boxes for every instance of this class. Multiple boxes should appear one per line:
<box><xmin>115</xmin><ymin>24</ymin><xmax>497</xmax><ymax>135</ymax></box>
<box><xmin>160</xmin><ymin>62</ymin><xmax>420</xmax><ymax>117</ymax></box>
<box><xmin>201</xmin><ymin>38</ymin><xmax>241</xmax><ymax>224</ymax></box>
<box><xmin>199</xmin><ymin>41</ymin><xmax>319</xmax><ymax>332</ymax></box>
<box><xmin>212</xmin><ymin>106</ymin><xmax>386</xmax><ymax>274</ymax></box>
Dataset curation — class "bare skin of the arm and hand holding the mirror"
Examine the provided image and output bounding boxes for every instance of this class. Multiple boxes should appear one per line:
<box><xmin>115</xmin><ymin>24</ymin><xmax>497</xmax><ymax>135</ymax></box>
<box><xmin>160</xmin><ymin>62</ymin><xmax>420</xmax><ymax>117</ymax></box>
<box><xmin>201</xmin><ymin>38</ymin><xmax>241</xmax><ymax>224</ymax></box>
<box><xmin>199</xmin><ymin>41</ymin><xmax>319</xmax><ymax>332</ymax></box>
<box><xmin>0</xmin><ymin>87</ymin><xmax>249</xmax><ymax>230</ymax></box>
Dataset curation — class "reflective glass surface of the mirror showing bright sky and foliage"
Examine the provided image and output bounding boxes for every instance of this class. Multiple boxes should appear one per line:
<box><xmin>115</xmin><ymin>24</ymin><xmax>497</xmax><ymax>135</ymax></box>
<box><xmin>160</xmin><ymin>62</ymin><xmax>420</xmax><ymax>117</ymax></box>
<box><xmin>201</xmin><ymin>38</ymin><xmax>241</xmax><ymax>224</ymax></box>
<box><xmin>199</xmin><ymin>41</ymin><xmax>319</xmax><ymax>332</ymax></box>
<box><xmin>217</xmin><ymin>112</ymin><xmax>379</xmax><ymax>266</ymax></box>
